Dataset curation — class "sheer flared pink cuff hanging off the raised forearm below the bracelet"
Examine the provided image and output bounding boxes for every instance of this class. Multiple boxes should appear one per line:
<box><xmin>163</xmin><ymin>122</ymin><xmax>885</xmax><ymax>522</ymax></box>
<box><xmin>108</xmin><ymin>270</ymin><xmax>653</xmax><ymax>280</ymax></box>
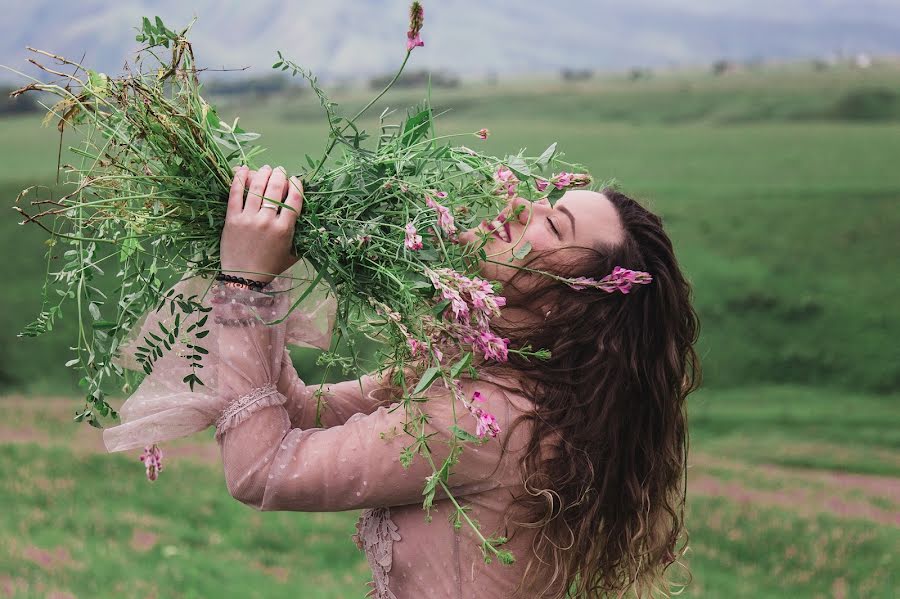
<box><xmin>103</xmin><ymin>261</ymin><xmax>335</xmax><ymax>452</ymax></box>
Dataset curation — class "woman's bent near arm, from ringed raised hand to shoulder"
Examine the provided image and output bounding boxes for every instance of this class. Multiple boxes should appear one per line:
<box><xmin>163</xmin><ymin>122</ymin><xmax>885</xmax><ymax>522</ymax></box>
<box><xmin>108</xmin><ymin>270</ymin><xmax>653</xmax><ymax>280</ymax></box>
<box><xmin>213</xmin><ymin>169</ymin><xmax>509</xmax><ymax>511</ymax></box>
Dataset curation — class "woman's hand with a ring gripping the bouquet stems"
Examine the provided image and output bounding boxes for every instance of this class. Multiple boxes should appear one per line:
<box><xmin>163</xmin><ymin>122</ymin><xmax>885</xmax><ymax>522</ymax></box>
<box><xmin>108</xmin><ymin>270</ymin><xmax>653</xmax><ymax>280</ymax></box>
<box><xmin>219</xmin><ymin>164</ymin><xmax>303</xmax><ymax>283</ymax></box>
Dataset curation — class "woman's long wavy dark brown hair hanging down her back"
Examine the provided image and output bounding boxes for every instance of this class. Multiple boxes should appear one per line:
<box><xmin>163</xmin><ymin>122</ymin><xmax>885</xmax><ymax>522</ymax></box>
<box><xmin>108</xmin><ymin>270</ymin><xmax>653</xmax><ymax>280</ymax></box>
<box><xmin>486</xmin><ymin>189</ymin><xmax>700</xmax><ymax>599</ymax></box>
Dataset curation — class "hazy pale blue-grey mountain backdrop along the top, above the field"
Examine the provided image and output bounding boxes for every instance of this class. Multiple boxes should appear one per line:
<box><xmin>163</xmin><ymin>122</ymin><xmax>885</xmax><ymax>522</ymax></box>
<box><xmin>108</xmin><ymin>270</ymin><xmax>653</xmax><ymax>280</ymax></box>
<box><xmin>0</xmin><ymin>0</ymin><xmax>900</xmax><ymax>81</ymax></box>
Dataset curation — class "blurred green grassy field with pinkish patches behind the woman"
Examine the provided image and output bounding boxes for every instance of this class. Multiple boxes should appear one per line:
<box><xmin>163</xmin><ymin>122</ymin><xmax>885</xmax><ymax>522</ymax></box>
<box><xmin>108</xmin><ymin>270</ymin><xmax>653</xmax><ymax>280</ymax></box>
<box><xmin>0</xmin><ymin>63</ymin><xmax>900</xmax><ymax>598</ymax></box>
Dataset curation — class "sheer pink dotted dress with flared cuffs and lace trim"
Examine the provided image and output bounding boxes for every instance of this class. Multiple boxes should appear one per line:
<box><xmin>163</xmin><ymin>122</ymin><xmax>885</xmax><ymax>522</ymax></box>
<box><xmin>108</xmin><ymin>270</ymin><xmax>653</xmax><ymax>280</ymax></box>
<box><xmin>103</xmin><ymin>262</ymin><xmax>552</xmax><ymax>599</ymax></box>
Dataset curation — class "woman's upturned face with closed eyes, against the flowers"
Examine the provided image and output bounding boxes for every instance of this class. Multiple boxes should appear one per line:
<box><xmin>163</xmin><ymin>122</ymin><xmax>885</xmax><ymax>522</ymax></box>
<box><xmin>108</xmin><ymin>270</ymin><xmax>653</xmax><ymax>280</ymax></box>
<box><xmin>459</xmin><ymin>189</ymin><xmax>624</xmax><ymax>282</ymax></box>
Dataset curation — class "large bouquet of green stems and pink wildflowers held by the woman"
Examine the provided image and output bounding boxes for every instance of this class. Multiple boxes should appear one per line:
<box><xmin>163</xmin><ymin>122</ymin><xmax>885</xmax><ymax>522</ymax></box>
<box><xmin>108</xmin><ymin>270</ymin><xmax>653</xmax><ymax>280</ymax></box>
<box><xmin>7</xmin><ymin>2</ymin><xmax>643</xmax><ymax>563</ymax></box>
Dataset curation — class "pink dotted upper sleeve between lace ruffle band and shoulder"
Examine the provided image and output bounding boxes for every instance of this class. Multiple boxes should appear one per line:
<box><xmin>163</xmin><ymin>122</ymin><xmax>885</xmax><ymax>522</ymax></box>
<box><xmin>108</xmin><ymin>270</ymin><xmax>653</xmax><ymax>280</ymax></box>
<box><xmin>216</xmin><ymin>385</ymin><xmax>521</xmax><ymax>511</ymax></box>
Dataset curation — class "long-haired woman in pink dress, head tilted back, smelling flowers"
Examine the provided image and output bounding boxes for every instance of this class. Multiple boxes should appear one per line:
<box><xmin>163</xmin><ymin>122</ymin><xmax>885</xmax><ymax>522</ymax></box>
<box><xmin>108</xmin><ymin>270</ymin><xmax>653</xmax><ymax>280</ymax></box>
<box><xmin>107</xmin><ymin>166</ymin><xmax>698</xmax><ymax>599</ymax></box>
